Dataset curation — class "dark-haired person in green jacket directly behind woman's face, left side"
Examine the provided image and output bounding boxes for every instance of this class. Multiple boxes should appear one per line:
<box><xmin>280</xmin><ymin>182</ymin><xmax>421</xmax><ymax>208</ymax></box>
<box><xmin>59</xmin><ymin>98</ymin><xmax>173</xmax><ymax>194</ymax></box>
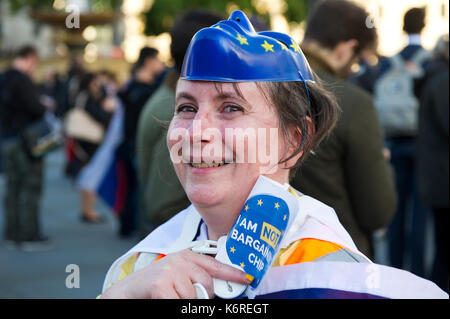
<box><xmin>136</xmin><ymin>9</ymin><xmax>223</xmax><ymax>235</ymax></box>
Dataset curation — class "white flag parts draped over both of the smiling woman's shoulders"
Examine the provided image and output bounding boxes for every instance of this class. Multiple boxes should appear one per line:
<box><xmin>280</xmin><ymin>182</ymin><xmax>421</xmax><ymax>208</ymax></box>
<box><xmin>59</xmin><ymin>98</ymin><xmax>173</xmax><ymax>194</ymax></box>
<box><xmin>103</xmin><ymin>195</ymin><xmax>448</xmax><ymax>299</ymax></box>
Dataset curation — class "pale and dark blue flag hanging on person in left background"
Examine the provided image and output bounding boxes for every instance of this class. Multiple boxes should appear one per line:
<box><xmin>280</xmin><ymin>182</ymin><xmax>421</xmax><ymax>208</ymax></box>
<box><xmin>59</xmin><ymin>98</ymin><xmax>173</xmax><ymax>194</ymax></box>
<box><xmin>77</xmin><ymin>102</ymin><xmax>127</xmax><ymax>214</ymax></box>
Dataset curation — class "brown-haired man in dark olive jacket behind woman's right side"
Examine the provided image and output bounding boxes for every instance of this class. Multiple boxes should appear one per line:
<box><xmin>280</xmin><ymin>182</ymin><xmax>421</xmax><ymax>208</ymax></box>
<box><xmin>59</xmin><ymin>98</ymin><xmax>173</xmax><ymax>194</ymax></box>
<box><xmin>291</xmin><ymin>0</ymin><xmax>396</xmax><ymax>257</ymax></box>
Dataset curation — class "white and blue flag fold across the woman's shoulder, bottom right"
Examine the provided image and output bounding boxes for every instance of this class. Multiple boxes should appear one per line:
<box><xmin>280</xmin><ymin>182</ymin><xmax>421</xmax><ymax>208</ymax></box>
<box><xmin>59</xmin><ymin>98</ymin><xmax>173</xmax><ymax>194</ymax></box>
<box><xmin>256</xmin><ymin>261</ymin><xmax>448</xmax><ymax>299</ymax></box>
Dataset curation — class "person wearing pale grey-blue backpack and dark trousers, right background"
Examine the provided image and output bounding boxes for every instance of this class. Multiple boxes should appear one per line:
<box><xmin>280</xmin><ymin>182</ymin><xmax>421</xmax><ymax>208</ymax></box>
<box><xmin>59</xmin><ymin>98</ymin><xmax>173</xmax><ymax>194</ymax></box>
<box><xmin>374</xmin><ymin>8</ymin><xmax>429</xmax><ymax>276</ymax></box>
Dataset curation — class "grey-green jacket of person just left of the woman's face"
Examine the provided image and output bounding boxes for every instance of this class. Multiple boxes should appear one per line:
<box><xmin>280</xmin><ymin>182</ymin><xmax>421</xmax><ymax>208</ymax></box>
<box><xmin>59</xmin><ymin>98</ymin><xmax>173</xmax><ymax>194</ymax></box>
<box><xmin>136</xmin><ymin>70</ymin><xmax>190</xmax><ymax>234</ymax></box>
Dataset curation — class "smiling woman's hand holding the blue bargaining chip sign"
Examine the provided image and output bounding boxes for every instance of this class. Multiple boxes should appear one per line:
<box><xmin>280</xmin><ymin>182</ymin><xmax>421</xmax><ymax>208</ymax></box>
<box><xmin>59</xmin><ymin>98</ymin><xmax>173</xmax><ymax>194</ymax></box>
<box><xmin>102</xmin><ymin>250</ymin><xmax>250</xmax><ymax>299</ymax></box>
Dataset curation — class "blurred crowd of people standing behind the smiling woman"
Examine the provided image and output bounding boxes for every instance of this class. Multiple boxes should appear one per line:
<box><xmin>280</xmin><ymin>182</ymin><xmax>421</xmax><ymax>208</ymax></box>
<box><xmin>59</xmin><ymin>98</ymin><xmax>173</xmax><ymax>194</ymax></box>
<box><xmin>0</xmin><ymin>0</ymin><xmax>449</xmax><ymax>292</ymax></box>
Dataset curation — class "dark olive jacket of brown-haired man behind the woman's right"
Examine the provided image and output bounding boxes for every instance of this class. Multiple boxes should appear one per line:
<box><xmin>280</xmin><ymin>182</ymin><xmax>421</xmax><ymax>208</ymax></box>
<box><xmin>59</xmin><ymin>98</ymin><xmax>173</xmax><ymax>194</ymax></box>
<box><xmin>291</xmin><ymin>48</ymin><xmax>396</xmax><ymax>257</ymax></box>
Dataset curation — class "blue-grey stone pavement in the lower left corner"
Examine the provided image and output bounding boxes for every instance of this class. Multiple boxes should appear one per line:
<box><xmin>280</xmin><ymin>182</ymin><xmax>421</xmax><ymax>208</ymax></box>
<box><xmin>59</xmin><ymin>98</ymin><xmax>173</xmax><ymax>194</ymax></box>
<box><xmin>0</xmin><ymin>150</ymin><xmax>136</xmax><ymax>298</ymax></box>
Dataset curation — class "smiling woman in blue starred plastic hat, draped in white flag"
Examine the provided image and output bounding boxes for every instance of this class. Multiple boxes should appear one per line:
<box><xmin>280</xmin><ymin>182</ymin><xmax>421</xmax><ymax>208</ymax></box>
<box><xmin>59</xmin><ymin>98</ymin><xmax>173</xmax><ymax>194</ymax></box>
<box><xmin>98</xmin><ymin>11</ymin><xmax>446</xmax><ymax>298</ymax></box>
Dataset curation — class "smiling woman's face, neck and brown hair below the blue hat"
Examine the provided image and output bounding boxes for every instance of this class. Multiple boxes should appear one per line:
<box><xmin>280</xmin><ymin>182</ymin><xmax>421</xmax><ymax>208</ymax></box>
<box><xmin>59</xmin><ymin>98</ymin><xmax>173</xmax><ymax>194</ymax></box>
<box><xmin>168</xmin><ymin>78</ymin><xmax>337</xmax><ymax>240</ymax></box>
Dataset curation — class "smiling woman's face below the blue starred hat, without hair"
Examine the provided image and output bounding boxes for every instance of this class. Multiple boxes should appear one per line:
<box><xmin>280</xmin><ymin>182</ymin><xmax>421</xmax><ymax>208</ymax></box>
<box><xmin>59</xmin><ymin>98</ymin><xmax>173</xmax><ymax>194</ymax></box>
<box><xmin>167</xmin><ymin>80</ymin><xmax>289</xmax><ymax>208</ymax></box>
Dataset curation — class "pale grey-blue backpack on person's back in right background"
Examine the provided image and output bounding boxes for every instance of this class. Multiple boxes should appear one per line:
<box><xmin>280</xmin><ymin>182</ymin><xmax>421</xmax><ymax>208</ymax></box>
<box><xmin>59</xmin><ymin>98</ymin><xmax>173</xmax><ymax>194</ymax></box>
<box><xmin>374</xmin><ymin>49</ymin><xmax>430</xmax><ymax>137</ymax></box>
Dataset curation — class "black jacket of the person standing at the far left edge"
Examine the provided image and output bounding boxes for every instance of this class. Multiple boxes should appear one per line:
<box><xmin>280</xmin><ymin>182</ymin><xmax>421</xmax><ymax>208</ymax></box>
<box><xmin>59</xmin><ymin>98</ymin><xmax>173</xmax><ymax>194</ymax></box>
<box><xmin>0</xmin><ymin>68</ymin><xmax>46</xmax><ymax>136</ymax></box>
